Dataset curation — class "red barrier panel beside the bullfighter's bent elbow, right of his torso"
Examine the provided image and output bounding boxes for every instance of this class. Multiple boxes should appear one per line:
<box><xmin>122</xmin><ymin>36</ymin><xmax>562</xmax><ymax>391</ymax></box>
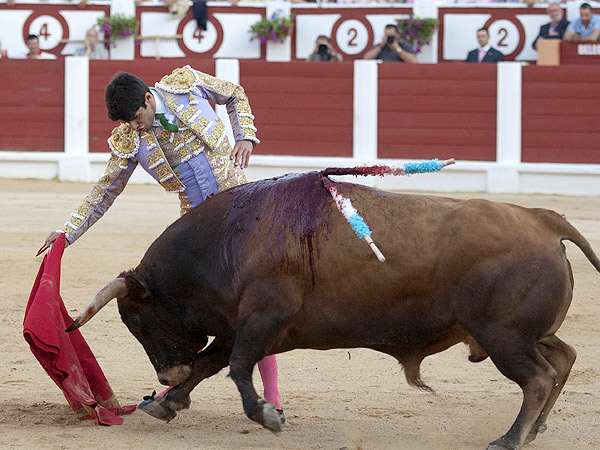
<box><xmin>240</xmin><ymin>60</ymin><xmax>353</xmax><ymax>157</ymax></box>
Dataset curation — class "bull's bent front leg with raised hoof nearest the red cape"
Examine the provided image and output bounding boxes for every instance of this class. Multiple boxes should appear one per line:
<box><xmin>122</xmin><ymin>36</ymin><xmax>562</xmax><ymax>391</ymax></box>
<box><xmin>139</xmin><ymin>339</ymin><xmax>231</xmax><ymax>422</ymax></box>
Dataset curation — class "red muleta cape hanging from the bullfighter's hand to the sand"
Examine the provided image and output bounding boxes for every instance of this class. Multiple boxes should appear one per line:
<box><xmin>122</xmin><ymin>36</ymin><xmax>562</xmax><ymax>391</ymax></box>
<box><xmin>23</xmin><ymin>235</ymin><xmax>136</xmax><ymax>425</ymax></box>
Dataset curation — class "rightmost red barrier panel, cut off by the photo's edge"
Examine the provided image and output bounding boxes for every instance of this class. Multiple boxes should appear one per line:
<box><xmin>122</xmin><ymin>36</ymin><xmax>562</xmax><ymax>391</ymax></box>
<box><xmin>522</xmin><ymin>66</ymin><xmax>600</xmax><ymax>164</ymax></box>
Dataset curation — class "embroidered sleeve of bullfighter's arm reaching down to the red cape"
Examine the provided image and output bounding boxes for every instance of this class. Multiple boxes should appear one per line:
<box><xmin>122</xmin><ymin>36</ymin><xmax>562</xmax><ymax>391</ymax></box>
<box><xmin>63</xmin><ymin>153</ymin><xmax>137</xmax><ymax>244</ymax></box>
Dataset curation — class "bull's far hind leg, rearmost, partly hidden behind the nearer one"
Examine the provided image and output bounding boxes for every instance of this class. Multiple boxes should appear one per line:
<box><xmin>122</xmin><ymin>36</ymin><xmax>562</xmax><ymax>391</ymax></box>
<box><xmin>525</xmin><ymin>336</ymin><xmax>577</xmax><ymax>444</ymax></box>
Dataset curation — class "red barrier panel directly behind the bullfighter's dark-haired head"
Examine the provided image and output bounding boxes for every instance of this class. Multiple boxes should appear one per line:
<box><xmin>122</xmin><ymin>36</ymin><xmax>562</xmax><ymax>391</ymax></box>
<box><xmin>90</xmin><ymin>59</ymin><xmax>215</xmax><ymax>152</ymax></box>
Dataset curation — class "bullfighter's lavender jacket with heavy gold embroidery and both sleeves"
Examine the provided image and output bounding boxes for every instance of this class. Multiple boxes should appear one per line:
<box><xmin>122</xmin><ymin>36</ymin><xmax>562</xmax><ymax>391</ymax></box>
<box><xmin>63</xmin><ymin>66</ymin><xmax>259</xmax><ymax>243</ymax></box>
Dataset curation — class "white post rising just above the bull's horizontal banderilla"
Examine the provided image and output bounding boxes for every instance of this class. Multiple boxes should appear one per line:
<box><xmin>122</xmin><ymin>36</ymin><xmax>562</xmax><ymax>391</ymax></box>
<box><xmin>352</xmin><ymin>59</ymin><xmax>378</xmax><ymax>164</ymax></box>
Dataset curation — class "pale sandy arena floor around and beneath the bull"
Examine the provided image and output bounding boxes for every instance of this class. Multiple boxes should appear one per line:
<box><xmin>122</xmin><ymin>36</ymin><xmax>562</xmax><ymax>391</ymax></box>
<box><xmin>0</xmin><ymin>179</ymin><xmax>600</xmax><ymax>450</ymax></box>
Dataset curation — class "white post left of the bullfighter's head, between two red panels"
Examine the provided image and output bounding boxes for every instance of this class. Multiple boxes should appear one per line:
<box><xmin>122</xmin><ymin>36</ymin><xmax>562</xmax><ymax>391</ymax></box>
<box><xmin>58</xmin><ymin>56</ymin><xmax>90</xmax><ymax>181</ymax></box>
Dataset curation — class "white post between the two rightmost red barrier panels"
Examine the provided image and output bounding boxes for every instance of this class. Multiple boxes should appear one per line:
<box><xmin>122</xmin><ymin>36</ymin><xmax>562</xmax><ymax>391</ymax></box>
<box><xmin>488</xmin><ymin>62</ymin><xmax>522</xmax><ymax>192</ymax></box>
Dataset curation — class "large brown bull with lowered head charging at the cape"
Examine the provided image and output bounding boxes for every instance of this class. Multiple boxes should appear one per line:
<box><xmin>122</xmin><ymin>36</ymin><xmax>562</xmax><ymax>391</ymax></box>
<box><xmin>67</xmin><ymin>172</ymin><xmax>600</xmax><ymax>450</ymax></box>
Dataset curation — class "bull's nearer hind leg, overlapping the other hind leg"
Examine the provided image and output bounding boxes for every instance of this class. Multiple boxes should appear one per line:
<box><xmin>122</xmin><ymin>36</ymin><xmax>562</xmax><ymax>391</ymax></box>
<box><xmin>478</xmin><ymin>329</ymin><xmax>557</xmax><ymax>450</ymax></box>
